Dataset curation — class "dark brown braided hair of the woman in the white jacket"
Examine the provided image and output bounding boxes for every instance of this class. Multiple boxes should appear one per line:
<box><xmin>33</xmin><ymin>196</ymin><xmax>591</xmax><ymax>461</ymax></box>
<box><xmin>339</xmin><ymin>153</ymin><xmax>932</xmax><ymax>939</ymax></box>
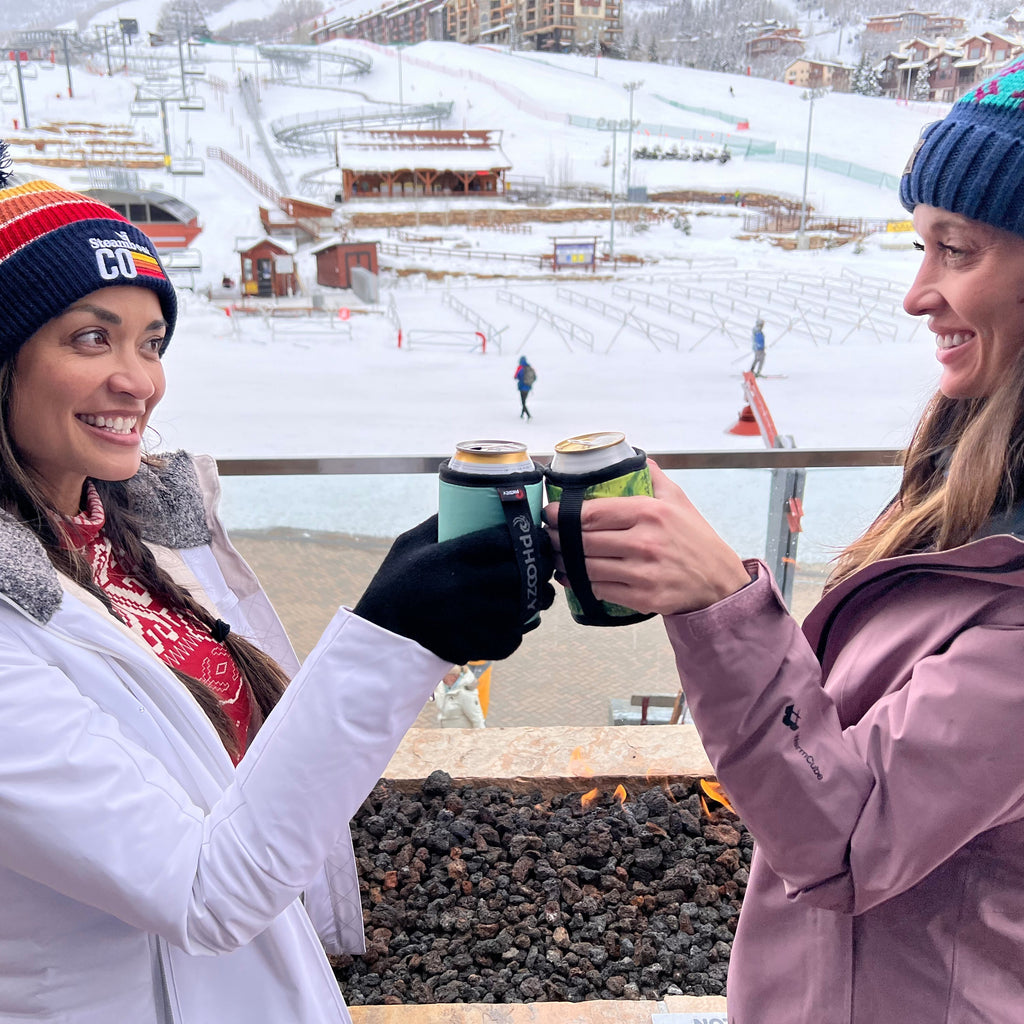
<box><xmin>0</xmin><ymin>357</ymin><xmax>288</xmax><ymax>757</ymax></box>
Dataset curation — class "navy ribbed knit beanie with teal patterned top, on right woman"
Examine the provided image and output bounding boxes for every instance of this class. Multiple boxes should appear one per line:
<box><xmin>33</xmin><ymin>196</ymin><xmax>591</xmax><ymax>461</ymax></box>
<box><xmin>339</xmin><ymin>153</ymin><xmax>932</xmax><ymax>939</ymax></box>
<box><xmin>899</xmin><ymin>57</ymin><xmax>1024</xmax><ymax>236</ymax></box>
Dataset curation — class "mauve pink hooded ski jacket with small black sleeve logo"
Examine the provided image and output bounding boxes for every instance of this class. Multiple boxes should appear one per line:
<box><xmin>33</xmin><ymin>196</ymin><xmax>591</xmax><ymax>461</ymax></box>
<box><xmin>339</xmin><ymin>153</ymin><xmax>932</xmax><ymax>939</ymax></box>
<box><xmin>666</xmin><ymin>536</ymin><xmax>1024</xmax><ymax>1024</ymax></box>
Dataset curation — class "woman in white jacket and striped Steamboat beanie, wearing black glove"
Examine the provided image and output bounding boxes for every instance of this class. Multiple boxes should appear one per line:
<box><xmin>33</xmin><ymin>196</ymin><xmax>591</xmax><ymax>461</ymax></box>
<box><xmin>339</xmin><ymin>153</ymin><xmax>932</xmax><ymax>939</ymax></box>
<box><xmin>0</xmin><ymin>151</ymin><xmax>553</xmax><ymax>1024</ymax></box>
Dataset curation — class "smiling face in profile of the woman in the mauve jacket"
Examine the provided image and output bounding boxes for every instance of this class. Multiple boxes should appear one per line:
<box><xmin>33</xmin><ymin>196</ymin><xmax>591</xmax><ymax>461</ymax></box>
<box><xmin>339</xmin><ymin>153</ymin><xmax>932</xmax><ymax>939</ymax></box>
<box><xmin>903</xmin><ymin>205</ymin><xmax>1024</xmax><ymax>398</ymax></box>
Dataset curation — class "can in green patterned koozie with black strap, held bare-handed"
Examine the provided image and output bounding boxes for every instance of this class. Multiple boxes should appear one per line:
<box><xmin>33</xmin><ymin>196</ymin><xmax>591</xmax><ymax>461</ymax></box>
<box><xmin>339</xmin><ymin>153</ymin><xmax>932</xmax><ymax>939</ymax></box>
<box><xmin>545</xmin><ymin>430</ymin><xmax>654</xmax><ymax>626</ymax></box>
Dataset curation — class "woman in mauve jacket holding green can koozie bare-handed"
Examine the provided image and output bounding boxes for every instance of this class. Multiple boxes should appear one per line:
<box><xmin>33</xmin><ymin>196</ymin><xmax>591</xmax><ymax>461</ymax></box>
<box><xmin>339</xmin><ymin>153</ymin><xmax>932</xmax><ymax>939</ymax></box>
<box><xmin>545</xmin><ymin>59</ymin><xmax>1024</xmax><ymax>1024</ymax></box>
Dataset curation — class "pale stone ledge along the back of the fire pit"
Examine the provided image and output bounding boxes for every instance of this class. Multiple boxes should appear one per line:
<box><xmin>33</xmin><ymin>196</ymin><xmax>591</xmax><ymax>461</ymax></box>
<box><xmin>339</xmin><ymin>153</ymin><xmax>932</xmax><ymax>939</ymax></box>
<box><xmin>384</xmin><ymin>724</ymin><xmax>714</xmax><ymax>796</ymax></box>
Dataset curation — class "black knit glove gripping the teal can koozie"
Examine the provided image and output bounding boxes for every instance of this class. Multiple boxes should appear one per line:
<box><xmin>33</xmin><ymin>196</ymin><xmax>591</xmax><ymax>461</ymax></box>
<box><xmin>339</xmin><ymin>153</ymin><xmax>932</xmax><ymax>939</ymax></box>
<box><xmin>355</xmin><ymin>515</ymin><xmax>555</xmax><ymax>665</ymax></box>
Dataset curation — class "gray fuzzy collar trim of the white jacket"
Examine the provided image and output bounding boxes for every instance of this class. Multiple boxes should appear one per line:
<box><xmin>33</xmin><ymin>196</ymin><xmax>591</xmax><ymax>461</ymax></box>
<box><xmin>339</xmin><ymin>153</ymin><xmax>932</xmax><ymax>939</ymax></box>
<box><xmin>0</xmin><ymin>452</ymin><xmax>210</xmax><ymax>623</ymax></box>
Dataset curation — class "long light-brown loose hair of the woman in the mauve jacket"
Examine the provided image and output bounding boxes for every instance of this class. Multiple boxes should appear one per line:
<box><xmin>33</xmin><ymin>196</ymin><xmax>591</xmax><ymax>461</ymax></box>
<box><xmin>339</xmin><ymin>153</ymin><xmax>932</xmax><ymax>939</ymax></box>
<box><xmin>828</xmin><ymin>347</ymin><xmax>1024</xmax><ymax>586</ymax></box>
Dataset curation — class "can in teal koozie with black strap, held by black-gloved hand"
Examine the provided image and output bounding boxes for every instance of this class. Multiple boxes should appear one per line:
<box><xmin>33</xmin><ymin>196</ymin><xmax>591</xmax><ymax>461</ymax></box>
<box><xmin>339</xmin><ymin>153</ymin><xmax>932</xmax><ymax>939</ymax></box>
<box><xmin>437</xmin><ymin>440</ymin><xmax>544</xmax><ymax>622</ymax></box>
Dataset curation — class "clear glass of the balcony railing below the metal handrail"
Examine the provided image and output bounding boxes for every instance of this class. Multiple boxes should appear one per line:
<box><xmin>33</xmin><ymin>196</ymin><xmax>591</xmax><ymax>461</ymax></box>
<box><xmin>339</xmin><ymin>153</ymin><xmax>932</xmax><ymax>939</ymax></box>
<box><xmin>214</xmin><ymin>466</ymin><xmax>898</xmax><ymax>741</ymax></box>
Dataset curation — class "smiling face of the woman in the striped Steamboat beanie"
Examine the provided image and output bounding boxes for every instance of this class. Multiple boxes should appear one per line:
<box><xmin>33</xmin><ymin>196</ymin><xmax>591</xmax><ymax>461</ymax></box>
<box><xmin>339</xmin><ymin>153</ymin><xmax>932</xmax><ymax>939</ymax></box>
<box><xmin>7</xmin><ymin>286</ymin><xmax>167</xmax><ymax>515</ymax></box>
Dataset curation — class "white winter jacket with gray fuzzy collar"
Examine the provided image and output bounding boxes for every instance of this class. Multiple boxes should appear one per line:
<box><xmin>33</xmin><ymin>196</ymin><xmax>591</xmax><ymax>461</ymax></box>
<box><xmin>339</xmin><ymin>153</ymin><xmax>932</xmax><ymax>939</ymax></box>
<box><xmin>0</xmin><ymin>453</ymin><xmax>447</xmax><ymax>1024</ymax></box>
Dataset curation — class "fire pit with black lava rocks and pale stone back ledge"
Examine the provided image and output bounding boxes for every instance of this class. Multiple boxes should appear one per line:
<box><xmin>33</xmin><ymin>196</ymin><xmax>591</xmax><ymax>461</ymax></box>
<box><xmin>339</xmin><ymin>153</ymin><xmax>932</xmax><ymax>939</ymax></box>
<box><xmin>334</xmin><ymin>726</ymin><xmax>752</xmax><ymax>1021</ymax></box>
